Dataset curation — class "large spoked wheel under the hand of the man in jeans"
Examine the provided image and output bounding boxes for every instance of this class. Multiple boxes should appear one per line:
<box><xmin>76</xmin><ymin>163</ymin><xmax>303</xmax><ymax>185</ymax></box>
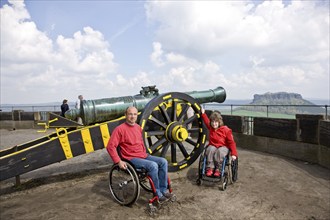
<box><xmin>109</xmin><ymin>163</ymin><xmax>140</xmax><ymax>206</ymax></box>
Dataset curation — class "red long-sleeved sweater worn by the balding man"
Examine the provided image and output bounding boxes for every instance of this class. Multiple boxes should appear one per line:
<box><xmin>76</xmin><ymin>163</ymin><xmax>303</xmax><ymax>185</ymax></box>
<box><xmin>107</xmin><ymin>122</ymin><xmax>147</xmax><ymax>163</ymax></box>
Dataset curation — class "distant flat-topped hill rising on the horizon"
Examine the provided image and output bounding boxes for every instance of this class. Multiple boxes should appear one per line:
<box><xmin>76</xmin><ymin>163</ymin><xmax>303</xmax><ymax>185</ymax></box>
<box><xmin>239</xmin><ymin>92</ymin><xmax>325</xmax><ymax>114</ymax></box>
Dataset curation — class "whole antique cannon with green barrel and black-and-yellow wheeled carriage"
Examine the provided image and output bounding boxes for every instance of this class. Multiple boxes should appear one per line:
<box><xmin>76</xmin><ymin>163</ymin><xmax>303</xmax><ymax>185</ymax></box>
<box><xmin>0</xmin><ymin>86</ymin><xmax>226</xmax><ymax>181</ymax></box>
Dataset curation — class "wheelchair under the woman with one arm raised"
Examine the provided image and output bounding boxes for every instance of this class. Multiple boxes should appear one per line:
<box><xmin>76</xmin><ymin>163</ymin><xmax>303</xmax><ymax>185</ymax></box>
<box><xmin>196</xmin><ymin>148</ymin><xmax>238</xmax><ymax>191</ymax></box>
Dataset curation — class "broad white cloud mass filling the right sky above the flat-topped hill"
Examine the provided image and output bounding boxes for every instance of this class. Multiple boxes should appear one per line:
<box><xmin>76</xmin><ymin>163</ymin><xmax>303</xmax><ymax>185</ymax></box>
<box><xmin>146</xmin><ymin>1</ymin><xmax>329</xmax><ymax>99</ymax></box>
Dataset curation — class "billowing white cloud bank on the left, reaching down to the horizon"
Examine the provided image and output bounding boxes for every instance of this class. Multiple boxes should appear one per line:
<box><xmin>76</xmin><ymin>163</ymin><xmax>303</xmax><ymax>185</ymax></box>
<box><xmin>1</xmin><ymin>1</ymin><xmax>118</xmax><ymax>103</ymax></box>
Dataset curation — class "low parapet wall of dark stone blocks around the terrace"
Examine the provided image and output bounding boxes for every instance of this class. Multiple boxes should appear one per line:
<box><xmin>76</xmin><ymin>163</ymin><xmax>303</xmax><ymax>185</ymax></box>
<box><xmin>0</xmin><ymin>111</ymin><xmax>330</xmax><ymax>169</ymax></box>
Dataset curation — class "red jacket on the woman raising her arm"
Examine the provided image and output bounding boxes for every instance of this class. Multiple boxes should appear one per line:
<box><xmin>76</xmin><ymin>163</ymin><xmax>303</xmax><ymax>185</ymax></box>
<box><xmin>202</xmin><ymin>113</ymin><xmax>238</xmax><ymax>157</ymax></box>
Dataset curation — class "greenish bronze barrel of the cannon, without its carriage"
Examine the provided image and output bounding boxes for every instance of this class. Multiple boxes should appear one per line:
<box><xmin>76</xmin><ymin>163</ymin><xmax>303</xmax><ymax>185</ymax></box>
<box><xmin>65</xmin><ymin>87</ymin><xmax>226</xmax><ymax>125</ymax></box>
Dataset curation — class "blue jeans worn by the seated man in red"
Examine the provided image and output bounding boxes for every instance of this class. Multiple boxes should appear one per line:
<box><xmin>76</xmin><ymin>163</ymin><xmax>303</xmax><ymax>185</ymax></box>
<box><xmin>130</xmin><ymin>155</ymin><xmax>167</xmax><ymax>198</ymax></box>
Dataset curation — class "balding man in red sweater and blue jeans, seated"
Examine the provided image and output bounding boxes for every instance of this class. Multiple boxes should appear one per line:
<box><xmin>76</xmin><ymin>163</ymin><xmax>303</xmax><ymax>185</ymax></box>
<box><xmin>107</xmin><ymin>106</ymin><xmax>173</xmax><ymax>202</ymax></box>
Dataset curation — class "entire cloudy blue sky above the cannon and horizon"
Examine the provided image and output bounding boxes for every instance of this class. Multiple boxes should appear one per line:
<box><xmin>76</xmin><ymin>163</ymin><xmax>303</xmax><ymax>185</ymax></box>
<box><xmin>0</xmin><ymin>0</ymin><xmax>330</xmax><ymax>104</ymax></box>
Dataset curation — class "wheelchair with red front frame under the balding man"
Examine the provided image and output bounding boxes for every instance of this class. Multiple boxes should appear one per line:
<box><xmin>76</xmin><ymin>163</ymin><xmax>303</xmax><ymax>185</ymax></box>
<box><xmin>109</xmin><ymin>159</ymin><xmax>176</xmax><ymax>215</ymax></box>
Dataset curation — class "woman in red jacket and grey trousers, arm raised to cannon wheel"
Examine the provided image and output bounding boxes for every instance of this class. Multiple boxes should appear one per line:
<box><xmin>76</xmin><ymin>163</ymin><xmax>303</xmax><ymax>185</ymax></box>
<box><xmin>202</xmin><ymin>108</ymin><xmax>237</xmax><ymax>177</ymax></box>
